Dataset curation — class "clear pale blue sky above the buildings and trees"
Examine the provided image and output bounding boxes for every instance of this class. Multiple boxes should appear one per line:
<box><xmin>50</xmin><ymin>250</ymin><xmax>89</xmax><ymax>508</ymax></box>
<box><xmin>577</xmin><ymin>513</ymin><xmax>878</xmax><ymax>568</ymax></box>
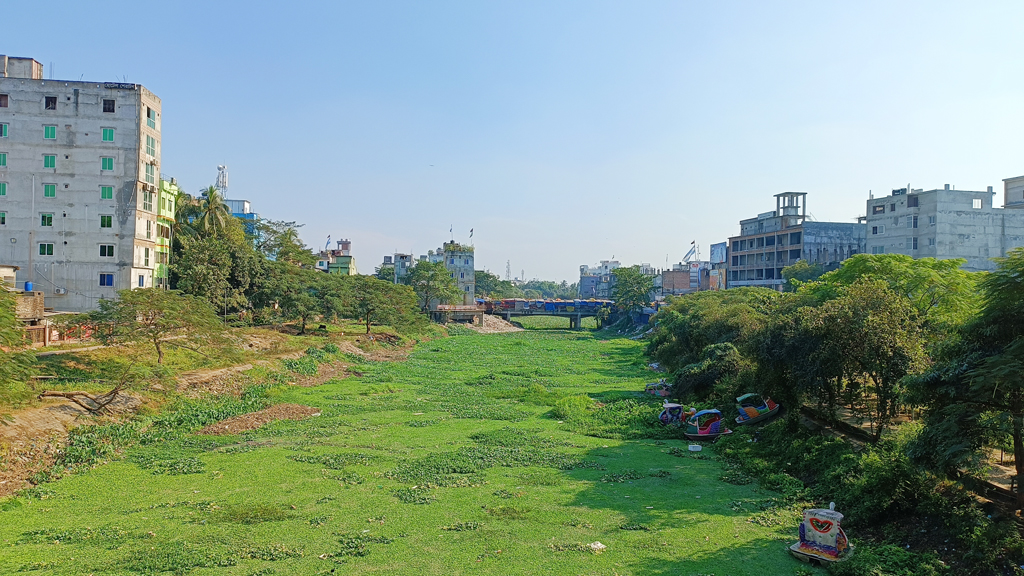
<box><xmin>0</xmin><ymin>0</ymin><xmax>1024</xmax><ymax>282</ymax></box>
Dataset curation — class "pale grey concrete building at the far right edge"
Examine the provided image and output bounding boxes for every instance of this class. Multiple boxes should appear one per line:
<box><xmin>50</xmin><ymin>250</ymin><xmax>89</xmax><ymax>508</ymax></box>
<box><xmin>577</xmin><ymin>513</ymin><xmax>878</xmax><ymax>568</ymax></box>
<box><xmin>867</xmin><ymin>184</ymin><xmax>1024</xmax><ymax>272</ymax></box>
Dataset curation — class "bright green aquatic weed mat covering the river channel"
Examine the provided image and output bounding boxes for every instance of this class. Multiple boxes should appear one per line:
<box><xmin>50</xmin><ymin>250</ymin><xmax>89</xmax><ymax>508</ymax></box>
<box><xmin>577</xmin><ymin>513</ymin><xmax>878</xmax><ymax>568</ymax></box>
<box><xmin>0</xmin><ymin>331</ymin><xmax>815</xmax><ymax>576</ymax></box>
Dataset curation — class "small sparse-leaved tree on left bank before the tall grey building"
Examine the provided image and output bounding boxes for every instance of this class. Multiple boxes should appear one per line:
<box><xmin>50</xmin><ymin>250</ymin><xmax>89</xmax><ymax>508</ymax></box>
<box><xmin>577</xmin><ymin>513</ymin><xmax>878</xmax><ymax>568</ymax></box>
<box><xmin>87</xmin><ymin>288</ymin><xmax>224</xmax><ymax>364</ymax></box>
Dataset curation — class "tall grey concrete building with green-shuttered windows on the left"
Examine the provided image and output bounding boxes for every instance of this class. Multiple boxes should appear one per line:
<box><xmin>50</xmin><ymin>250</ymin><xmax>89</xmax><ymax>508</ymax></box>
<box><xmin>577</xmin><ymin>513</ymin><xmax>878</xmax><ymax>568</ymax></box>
<box><xmin>0</xmin><ymin>55</ymin><xmax>161</xmax><ymax>312</ymax></box>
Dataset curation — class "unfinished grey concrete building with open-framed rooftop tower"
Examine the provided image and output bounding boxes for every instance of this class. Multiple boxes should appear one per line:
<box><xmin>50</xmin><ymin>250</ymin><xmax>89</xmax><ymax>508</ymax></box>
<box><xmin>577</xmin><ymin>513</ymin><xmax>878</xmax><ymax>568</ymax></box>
<box><xmin>726</xmin><ymin>192</ymin><xmax>865</xmax><ymax>289</ymax></box>
